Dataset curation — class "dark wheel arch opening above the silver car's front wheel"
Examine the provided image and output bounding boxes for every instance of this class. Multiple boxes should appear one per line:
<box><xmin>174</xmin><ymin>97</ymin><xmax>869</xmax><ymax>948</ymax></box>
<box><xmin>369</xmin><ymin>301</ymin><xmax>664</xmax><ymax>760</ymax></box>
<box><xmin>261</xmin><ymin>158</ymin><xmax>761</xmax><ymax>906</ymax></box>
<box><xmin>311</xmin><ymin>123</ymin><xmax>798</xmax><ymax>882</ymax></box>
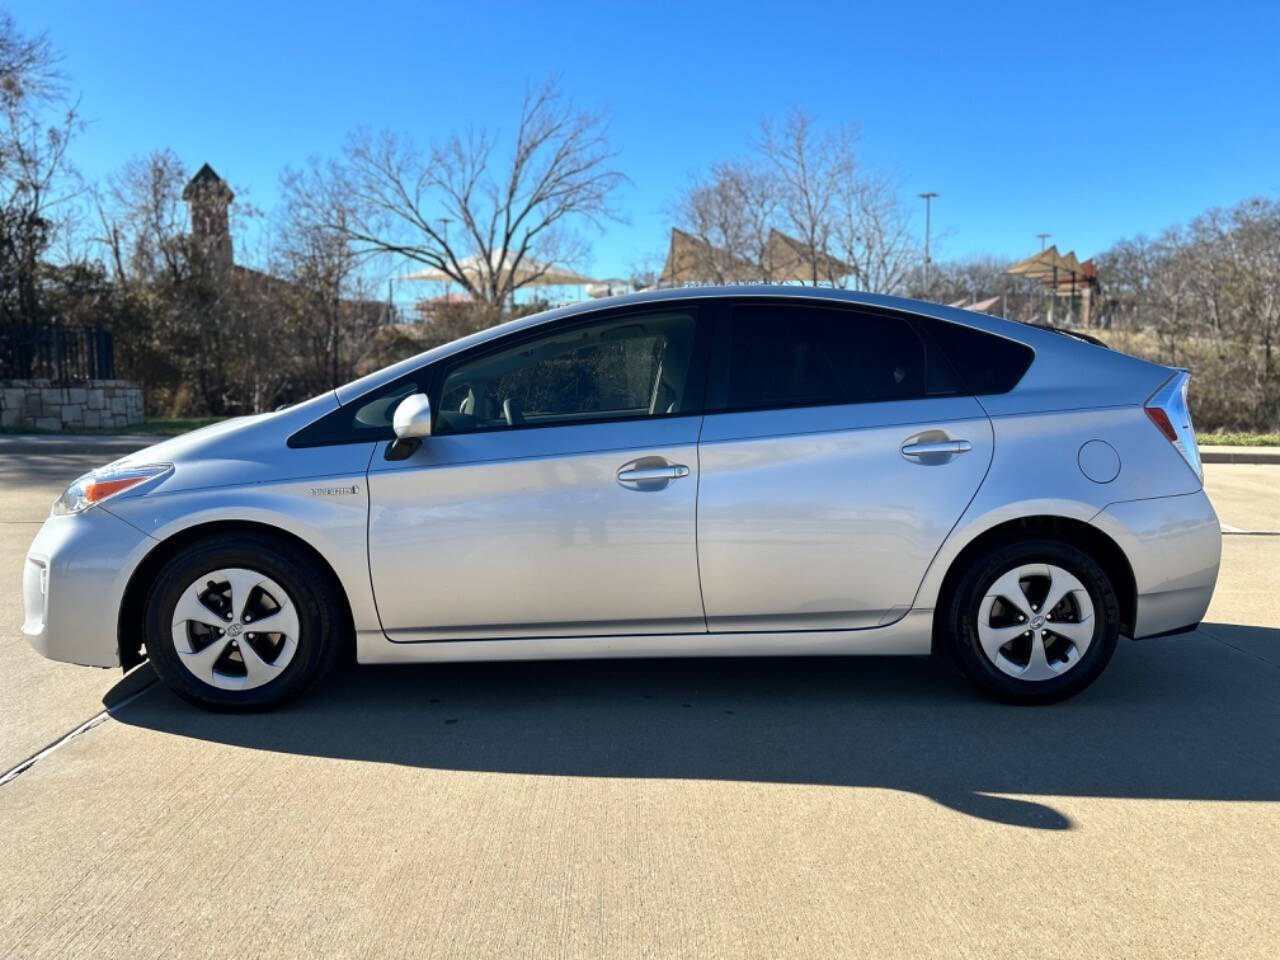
<box><xmin>116</xmin><ymin>520</ymin><xmax>355</xmax><ymax>669</ymax></box>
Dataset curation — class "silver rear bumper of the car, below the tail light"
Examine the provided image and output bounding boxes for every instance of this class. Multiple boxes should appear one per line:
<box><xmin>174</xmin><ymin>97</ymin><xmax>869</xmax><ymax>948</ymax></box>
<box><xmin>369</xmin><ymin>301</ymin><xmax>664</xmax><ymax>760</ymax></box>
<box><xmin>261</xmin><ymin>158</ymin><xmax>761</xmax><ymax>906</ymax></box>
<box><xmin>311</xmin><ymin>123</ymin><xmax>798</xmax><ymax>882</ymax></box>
<box><xmin>1093</xmin><ymin>490</ymin><xmax>1222</xmax><ymax>639</ymax></box>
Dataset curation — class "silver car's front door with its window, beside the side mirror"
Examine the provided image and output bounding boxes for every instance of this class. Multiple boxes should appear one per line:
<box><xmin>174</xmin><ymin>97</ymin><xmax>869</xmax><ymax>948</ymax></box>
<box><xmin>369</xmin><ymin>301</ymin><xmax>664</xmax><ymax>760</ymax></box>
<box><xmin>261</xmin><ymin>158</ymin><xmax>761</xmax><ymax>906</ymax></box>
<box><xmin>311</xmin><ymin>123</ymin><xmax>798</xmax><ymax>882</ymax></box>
<box><xmin>369</xmin><ymin>307</ymin><xmax>705</xmax><ymax>641</ymax></box>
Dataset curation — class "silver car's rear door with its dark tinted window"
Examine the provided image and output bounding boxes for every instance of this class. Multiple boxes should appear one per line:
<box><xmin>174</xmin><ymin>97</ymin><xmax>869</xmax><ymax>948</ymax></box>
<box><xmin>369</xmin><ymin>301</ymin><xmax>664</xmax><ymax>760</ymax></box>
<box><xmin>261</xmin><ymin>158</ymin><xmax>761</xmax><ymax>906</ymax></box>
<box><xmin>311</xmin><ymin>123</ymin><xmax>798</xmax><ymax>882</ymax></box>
<box><xmin>698</xmin><ymin>298</ymin><xmax>992</xmax><ymax>632</ymax></box>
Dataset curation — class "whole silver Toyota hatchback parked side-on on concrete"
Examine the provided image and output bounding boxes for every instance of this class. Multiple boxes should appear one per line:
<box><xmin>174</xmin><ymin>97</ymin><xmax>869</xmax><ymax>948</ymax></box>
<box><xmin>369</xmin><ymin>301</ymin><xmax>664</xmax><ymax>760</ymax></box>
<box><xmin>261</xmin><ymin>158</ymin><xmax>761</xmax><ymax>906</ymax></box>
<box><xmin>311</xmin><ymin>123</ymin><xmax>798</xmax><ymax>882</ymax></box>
<box><xmin>23</xmin><ymin>287</ymin><xmax>1221</xmax><ymax>709</ymax></box>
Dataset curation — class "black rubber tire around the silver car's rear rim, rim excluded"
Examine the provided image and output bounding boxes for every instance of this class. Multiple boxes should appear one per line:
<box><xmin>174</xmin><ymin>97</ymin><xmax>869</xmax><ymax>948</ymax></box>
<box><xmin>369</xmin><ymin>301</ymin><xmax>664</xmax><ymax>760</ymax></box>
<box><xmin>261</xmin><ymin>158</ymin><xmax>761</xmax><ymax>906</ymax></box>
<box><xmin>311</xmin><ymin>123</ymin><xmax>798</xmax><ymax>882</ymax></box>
<box><xmin>943</xmin><ymin>539</ymin><xmax>1120</xmax><ymax>704</ymax></box>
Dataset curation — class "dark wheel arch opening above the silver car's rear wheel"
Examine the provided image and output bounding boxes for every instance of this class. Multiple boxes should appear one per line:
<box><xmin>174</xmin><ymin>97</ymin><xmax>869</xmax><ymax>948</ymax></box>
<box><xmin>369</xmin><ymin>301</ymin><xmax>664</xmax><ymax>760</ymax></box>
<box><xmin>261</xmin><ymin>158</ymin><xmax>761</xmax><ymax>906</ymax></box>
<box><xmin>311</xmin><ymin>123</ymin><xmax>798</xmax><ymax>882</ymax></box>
<box><xmin>933</xmin><ymin>515</ymin><xmax>1138</xmax><ymax>649</ymax></box>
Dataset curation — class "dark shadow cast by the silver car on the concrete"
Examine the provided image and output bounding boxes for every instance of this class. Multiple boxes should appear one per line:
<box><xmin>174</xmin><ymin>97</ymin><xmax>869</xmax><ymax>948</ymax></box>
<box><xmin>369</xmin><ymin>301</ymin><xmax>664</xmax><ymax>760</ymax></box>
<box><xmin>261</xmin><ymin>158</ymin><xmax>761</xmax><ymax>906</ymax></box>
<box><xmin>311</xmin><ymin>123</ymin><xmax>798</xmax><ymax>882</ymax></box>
<box><xmin>113</xmin><ymin>625</ymin><xmax>1280</xmax><ymax>829</ymax></box>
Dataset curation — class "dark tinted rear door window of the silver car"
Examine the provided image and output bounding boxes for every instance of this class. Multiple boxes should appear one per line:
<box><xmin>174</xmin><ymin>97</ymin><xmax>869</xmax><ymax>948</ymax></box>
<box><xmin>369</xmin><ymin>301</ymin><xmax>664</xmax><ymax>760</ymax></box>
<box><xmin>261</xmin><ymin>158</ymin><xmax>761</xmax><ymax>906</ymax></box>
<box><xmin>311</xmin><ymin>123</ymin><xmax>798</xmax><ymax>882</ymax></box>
<box><xmin>713</xmin><ymin>303</ymin><xmax>955</xmax><ymax>410</ymax></box>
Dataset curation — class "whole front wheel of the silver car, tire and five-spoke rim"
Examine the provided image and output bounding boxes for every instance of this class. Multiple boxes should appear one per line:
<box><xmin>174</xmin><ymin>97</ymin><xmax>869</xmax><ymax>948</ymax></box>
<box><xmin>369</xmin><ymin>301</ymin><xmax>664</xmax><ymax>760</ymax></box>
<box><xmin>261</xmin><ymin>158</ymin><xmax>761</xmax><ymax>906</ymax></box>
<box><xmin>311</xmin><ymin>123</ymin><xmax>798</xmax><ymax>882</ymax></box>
<box><xmin>146</xmin><ymin>536</ymin><xmax>342</xmax><ymax>710</ymax></box>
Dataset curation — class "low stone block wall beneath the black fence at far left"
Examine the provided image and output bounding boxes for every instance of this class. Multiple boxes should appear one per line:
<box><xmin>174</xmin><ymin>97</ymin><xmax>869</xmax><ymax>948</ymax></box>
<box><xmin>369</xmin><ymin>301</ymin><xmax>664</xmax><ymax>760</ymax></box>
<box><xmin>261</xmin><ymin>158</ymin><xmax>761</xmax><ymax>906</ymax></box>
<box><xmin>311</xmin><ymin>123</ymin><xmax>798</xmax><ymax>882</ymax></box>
<box><xmin>0</xmin><ymin>380</ymin><xmax>143</xmax><ymax>433</ymax></box>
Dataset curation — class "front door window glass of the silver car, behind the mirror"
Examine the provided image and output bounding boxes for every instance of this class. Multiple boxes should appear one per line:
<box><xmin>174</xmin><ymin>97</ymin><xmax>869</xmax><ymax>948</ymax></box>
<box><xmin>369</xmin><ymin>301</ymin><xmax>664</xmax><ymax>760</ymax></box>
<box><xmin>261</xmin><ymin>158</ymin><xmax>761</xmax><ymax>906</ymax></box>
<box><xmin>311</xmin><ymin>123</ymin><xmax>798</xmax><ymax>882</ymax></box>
<box><xmin>435</xmin><ymin>312</ymin><xmax>700</xmax><ymax>434</ymax></box>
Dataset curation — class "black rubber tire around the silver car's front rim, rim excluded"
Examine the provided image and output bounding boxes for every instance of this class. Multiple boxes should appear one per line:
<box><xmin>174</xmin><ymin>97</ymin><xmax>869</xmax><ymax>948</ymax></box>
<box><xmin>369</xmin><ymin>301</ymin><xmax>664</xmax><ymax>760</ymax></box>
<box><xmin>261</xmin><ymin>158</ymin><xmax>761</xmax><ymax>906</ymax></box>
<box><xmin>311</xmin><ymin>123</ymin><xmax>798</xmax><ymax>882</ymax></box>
<box><xmin>145</xmin><ymin>534</ymin><xmax>346</xmax><ymax>712</ymax></box>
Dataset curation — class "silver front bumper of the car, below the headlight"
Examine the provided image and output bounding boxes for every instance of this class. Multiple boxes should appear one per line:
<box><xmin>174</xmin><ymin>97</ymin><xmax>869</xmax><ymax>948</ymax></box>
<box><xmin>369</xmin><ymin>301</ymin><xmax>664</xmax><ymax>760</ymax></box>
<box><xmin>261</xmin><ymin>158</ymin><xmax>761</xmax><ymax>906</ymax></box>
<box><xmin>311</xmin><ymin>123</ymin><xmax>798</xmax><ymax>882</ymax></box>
<box><xmin>22</xmin><ymin>507</ymin><xmax>155</xmax><ymax>667</ymax></box>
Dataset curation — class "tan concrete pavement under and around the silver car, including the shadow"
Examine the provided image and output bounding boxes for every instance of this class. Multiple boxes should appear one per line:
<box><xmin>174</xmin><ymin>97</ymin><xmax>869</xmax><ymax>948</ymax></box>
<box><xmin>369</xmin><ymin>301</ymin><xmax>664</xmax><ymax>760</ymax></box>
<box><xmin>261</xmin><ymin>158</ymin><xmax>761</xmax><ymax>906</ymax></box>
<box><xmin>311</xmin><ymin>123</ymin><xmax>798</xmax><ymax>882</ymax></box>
<box><xmin>0</xmin><ymin>457</ymin><xmax>1280</xmax><ymax>957</ymax></box>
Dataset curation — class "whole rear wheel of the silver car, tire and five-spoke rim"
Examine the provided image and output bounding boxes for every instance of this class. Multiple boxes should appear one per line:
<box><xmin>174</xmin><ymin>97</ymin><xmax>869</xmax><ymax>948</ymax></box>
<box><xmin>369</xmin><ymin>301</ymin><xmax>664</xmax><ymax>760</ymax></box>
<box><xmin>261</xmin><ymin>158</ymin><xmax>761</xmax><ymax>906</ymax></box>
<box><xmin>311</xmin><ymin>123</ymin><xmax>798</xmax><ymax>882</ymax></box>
<box><xmin>947</xmin><ymin>540</ymin><xmax>1120</xmax><ymax>704</ymax></box>
